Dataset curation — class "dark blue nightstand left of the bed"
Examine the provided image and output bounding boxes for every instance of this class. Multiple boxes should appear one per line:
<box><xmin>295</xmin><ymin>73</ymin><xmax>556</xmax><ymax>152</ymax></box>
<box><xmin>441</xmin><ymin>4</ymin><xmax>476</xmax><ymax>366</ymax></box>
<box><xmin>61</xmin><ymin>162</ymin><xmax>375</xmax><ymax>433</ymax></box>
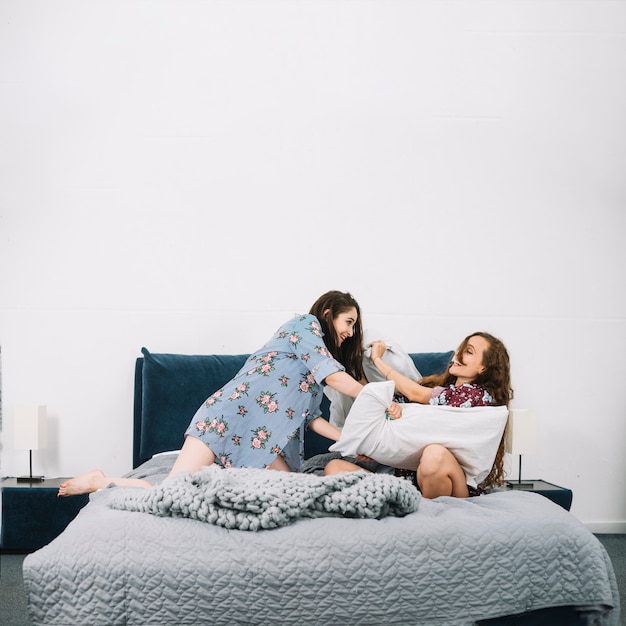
<box><xmin>0</xmin><ymin>478</ymin><xmax>89</xmax><ymax>552</ymax></box>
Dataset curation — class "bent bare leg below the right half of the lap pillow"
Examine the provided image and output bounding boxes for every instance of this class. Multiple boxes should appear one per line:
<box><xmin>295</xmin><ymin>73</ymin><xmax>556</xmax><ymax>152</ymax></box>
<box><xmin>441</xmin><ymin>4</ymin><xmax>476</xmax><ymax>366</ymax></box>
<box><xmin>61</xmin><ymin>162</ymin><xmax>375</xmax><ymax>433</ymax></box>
<box><xmin>417</xmin><ymin>443</ymin><xmax>469</xmax><ymax>498</ymax></box>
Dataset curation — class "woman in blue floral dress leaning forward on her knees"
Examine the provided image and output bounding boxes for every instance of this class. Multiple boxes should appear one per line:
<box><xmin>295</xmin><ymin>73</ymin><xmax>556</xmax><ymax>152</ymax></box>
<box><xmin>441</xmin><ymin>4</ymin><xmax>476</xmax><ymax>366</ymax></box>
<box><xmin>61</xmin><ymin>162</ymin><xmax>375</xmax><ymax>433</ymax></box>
<box><xmin>59</xmin><ymin>291</ymin><xmax>400</xmax><ymax>496</ymax></box>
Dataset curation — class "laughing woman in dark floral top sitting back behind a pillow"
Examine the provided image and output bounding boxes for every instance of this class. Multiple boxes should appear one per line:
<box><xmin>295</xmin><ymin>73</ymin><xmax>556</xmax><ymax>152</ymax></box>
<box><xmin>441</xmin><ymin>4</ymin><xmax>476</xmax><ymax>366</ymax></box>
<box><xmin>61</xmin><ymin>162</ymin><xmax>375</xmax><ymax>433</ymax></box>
<box><xmin>324</xmin><ymin>332</ymin><xmax>513</xmax><ymax>498</ymax></box>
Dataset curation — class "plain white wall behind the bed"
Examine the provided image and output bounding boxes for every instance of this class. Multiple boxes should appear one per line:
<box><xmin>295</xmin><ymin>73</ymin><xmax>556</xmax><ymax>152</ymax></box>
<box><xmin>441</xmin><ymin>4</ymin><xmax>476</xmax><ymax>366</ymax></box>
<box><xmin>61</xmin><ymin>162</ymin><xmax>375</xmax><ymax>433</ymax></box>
<box><xmin>0</xmin><ymin>0</ymin><xmax>626</xmax><ymax>532</ymax></box>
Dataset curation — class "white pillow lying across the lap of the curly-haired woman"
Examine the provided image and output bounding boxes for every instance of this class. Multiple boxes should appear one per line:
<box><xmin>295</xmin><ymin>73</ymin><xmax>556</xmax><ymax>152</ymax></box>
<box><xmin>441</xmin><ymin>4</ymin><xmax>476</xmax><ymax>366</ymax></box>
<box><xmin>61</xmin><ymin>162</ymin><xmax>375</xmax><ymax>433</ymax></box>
<box><xmin>329</xmin><ymin>381</ymin><xmax>509</xmax><ymax>487</ymax></box>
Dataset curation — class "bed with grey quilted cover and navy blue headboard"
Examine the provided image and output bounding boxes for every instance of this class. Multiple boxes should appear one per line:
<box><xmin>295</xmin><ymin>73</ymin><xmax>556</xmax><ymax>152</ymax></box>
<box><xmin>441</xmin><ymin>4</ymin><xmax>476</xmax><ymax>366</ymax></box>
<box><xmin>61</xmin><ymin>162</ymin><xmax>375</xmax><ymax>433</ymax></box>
<box><xmin>23</xmin><ymin>349</ymin><xmax>620</xmax><ymax>626</ymax></box>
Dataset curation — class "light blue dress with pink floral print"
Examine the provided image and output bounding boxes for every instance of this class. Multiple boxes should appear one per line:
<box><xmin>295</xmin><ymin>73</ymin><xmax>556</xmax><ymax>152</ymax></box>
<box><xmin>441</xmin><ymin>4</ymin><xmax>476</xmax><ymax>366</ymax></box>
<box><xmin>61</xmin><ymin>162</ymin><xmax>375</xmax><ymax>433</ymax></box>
<box><xmin>185</xmin><ymin>315</ymin><xmax>345</xmax><ymax>471</ymax></box>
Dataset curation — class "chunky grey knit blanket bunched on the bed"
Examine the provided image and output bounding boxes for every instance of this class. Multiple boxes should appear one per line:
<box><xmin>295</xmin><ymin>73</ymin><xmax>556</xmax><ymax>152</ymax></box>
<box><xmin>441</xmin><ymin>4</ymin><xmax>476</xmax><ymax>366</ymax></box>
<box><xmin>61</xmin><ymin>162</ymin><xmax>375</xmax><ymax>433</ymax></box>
<box><xmin>110</xmin><ymin>466</ymin><xmax>420</xmax><ymax>530</ymax></box>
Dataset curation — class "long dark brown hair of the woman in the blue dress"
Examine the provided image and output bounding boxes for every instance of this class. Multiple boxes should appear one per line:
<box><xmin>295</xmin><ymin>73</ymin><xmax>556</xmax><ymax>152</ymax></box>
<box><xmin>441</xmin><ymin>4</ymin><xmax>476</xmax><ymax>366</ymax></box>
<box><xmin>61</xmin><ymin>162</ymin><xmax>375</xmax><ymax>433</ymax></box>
<box><xmin>309</xmin><ymin>291</ymin><xmax>364</xmax><ymax>380</ymax></box>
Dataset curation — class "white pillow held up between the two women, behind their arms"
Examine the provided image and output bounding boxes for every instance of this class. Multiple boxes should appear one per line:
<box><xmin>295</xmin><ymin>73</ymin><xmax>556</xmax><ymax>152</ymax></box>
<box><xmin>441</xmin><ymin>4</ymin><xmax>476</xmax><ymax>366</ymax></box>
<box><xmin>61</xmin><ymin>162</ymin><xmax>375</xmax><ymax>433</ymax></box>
<box><xmin>324</xmin><ymin>328</ymin><xmax>422</xmax><ymax>428</ymax></box>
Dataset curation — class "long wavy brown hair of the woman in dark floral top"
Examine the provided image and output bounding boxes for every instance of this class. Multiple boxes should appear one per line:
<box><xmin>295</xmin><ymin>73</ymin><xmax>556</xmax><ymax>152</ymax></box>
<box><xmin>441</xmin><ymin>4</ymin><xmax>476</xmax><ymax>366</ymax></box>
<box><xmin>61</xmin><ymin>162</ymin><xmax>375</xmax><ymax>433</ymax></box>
<box><xmin>419</xmin><ymin>332</ymin><xmax>513</xmax><ymax>488</ymax></box>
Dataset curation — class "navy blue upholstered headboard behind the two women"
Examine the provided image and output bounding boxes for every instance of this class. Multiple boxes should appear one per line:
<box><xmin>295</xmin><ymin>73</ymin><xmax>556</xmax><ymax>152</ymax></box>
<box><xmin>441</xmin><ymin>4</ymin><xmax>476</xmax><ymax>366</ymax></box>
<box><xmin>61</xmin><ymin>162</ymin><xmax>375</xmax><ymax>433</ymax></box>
<box><xmin>133</xmin><ymin>348</ymin><xmax>453</xmax><ymax>467</ymax></box>
